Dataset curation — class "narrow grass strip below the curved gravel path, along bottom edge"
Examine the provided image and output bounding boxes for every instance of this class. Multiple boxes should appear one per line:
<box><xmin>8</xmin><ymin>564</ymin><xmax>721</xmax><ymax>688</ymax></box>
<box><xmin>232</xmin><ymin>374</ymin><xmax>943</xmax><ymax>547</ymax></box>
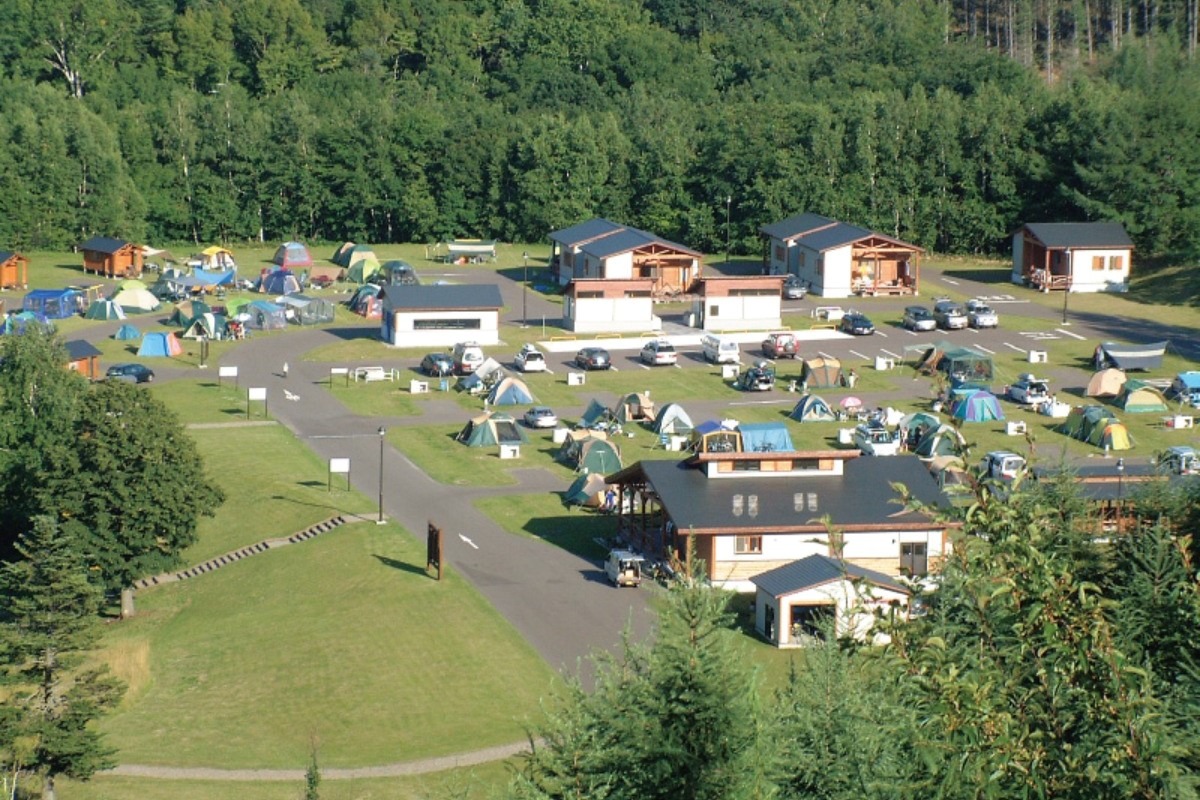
<box><xmin>56</xmin><ymin>756</ymin><xmax>511</xmax><ymax>800</ymax></box>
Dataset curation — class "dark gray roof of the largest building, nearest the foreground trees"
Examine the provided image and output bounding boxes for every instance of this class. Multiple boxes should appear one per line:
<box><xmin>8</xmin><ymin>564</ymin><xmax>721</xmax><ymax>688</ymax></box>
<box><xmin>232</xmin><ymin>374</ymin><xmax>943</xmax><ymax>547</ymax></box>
<box><xmin>640</xmin><ymin>453</ymin><xmax>949</xmax><ymax>533</ymax></box>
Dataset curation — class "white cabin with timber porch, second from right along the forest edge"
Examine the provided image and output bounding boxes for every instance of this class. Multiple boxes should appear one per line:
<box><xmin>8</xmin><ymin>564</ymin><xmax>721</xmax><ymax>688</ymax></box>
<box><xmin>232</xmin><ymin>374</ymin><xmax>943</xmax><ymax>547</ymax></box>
<box><xmin>760</xmin><ymin>213</ymin><xmax>925</xmax><ymax>297</ymax></box>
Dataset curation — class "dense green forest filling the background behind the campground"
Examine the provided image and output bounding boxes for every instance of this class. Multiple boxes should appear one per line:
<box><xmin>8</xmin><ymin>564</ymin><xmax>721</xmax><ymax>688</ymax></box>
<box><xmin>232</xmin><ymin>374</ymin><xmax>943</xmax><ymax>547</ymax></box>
<box><xmin>0</xmin><ymin>0</ymin><xmax>1200</xmax><ymax>261</ymax></box>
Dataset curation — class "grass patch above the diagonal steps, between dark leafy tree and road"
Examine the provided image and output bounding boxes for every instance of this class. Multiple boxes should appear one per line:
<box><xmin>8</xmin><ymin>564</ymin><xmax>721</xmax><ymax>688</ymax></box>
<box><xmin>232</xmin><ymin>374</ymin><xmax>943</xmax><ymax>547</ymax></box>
<box><xmin>184</xmin><ymin>426</ymin><xmax>374</xmax><ymax>564</ymax></box>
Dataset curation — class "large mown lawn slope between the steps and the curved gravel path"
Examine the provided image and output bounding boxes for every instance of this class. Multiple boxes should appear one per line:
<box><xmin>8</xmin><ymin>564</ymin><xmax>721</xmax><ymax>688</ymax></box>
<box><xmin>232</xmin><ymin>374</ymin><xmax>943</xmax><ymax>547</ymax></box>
<box><xmin>101</xmin><ymin>523</ymin><xmax>553</xmax><ymax>769</ymax></box>
